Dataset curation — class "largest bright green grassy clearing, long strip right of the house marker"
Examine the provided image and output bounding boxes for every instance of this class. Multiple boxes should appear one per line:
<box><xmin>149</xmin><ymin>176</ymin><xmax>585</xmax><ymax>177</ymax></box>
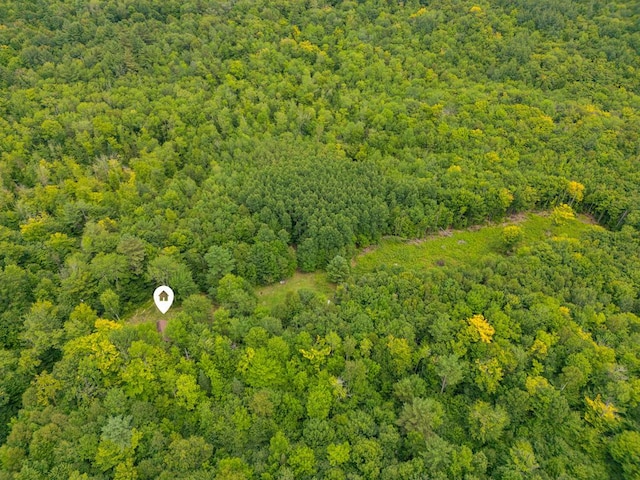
<box><xmin>354</xmin><ymin>213</ymin><xmax>601</xmax><ymax>273</ymax></box>
